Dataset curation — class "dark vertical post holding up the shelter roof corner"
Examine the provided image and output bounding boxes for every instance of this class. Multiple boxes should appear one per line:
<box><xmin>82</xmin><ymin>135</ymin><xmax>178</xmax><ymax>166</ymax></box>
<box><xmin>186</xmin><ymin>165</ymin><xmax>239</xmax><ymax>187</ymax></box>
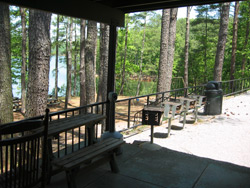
<box><xmin>106</xmin><ymin>24</ymin><xmax>117</xmax><ymax>132</ymax></box>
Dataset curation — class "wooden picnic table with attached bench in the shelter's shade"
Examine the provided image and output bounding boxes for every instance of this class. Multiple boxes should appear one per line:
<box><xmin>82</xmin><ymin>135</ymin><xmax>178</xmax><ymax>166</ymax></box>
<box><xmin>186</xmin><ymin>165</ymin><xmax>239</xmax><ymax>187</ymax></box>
<box><xmin>48</xmin><ymin>114</ymin><xmax>124</xmax><ymax>188</ymax></box>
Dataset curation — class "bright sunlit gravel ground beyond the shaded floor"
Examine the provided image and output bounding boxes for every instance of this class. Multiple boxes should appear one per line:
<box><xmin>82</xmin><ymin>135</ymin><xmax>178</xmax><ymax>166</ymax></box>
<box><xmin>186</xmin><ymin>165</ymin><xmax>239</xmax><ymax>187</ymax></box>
<box><xmin>125</xmin><ymin>92</ymin><xmax>250</xmax><ymax>167</ymax></box>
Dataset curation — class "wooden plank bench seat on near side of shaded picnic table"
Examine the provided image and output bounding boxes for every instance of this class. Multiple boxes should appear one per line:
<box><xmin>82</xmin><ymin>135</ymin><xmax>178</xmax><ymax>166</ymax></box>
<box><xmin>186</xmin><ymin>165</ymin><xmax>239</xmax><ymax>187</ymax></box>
<box><xmin>52</xmin><ymin>138</ymin><xmax>124</xmax><ymax>188</ymax></box>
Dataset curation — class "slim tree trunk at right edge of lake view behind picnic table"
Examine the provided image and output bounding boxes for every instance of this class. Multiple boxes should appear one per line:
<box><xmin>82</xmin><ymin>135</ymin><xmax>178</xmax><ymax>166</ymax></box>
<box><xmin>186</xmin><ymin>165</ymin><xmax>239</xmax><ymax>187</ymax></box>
<box><xmin>65</xmin><ymin>18</ymin><xmax>73</xmax><ymax>109</ymax></box>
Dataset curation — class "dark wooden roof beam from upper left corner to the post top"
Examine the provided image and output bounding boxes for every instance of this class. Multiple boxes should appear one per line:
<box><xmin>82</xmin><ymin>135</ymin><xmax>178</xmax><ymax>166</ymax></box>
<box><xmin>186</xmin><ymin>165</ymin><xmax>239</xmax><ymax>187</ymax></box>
<box><xmin>0</xmin><ymin>0</ymin><xmax>125</xmax><ymax>27</ymax></box>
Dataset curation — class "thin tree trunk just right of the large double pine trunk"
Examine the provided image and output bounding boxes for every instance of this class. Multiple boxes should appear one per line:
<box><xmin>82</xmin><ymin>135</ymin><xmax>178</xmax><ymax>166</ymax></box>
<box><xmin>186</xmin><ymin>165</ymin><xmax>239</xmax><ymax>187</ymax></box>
<box><xmin>184</xmin><ymin>7</ymin><xmax>191</xmax><ymax>87</ymax></box>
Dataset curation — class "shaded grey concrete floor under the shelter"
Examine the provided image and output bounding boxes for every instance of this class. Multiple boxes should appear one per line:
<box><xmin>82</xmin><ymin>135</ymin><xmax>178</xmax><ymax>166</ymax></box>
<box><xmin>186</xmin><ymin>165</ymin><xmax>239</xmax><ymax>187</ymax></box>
<box><xmin>47</xmin><ymin>144</ymin><xmax>250</xmax><ymax>188</ymax></box>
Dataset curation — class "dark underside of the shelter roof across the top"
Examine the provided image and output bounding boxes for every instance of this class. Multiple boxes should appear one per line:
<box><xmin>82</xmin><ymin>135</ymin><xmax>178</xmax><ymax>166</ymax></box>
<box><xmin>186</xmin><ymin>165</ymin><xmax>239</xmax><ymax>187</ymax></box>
<box><xmin>0</xmin><ymin>0</ymin><xmax>236</xmax><ymax>26</ymax></box>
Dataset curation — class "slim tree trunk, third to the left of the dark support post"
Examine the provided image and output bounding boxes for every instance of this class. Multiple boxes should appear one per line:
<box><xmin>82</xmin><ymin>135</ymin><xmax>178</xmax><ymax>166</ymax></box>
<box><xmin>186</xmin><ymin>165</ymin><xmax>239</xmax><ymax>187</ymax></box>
<box><xmin>80</xmin><ymin>19</ymin><xmax>87</xmax><ymax>106</ymax></box>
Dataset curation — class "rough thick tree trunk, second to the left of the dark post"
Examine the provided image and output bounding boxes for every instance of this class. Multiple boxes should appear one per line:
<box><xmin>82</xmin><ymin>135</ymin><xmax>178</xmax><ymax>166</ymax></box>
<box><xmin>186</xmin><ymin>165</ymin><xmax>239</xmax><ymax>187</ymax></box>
<box><xmin>85</xmin><ymin>21</ymin><xmax>97</xmax><ymax>104</ymax></box>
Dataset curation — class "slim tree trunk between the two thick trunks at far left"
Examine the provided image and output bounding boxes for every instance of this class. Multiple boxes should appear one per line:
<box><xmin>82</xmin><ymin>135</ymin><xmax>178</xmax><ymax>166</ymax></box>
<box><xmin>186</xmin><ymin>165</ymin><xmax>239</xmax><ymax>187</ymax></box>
<box><xmin>20</xmin><ymin>8</ymin><xmax>27</xmax><ymax>114</ymax></box>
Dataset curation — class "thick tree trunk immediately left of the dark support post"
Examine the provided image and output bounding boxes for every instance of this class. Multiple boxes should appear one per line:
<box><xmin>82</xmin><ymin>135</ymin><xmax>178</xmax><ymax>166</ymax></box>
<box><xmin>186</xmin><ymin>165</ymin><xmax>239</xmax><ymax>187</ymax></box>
<box><xmin>97</xmin><ymin>23</ymin><xmax>109</xmax><ymax>102</ymax></box>
